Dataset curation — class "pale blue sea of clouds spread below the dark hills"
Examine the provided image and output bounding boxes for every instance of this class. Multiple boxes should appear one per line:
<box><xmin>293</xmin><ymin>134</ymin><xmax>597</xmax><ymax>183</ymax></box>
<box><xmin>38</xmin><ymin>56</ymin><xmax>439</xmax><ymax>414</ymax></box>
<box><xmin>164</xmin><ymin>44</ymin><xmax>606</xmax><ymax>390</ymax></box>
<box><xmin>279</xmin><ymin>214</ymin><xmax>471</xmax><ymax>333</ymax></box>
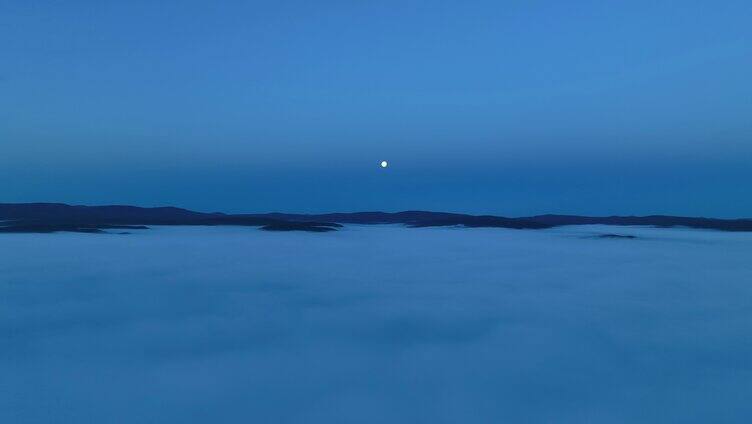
<box><xmin>0</xmin><ymin>226</ymin><xmax>752</xmax><ymax>424</ymax></box>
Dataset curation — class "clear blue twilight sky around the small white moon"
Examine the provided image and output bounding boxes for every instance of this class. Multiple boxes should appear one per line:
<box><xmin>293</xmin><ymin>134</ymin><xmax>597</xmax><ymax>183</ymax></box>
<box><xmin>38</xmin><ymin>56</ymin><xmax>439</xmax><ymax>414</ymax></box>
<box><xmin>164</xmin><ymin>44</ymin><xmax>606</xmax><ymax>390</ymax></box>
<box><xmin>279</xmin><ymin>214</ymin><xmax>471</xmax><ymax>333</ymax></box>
<box><xmin>0</xmin><ymin>0</ymin><xmax>752</xmax><ymax>217</ymax></box>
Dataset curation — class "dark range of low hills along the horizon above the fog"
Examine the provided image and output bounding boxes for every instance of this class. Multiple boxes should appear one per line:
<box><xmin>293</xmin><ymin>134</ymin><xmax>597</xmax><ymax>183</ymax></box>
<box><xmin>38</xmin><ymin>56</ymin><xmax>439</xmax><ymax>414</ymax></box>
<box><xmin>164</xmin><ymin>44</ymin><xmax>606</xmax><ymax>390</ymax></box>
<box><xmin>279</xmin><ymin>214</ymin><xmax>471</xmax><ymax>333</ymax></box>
<box><xmin>0</xmin><ymin>203</ymin><xmax>752</xmax><ymax>233</ymax></box>
